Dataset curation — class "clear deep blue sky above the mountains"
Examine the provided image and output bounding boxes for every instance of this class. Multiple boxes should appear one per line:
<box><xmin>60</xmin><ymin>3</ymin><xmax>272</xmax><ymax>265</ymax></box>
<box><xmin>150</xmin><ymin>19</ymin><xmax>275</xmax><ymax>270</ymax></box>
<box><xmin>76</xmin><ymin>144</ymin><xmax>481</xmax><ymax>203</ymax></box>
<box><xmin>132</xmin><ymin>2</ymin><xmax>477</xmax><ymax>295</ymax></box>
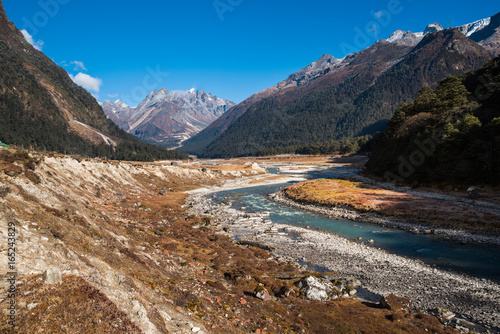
<box><xmin>3</xmin><ymin>0</ymin><xmax>500</xmax><ymax>106</ymax></box>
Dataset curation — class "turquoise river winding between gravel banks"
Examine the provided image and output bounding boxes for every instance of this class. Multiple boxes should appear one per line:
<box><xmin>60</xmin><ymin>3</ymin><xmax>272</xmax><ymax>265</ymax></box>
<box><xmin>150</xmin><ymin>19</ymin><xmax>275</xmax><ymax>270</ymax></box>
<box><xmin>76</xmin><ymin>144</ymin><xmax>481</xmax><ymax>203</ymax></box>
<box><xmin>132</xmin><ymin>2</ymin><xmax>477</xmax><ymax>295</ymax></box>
<box><xmin>212</xmin><ymin>170</ymin><xmax>500</xmax><ymax>282</ymax></box>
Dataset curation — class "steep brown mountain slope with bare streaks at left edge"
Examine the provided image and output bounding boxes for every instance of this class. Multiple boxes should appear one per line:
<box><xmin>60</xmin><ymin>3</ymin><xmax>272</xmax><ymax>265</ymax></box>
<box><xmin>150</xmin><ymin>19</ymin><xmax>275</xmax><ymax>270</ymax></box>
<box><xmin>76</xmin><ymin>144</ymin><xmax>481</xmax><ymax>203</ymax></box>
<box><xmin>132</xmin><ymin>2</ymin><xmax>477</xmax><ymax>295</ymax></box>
<box><xmin>0</xmin><ymin>2</ymin><xmax>186</xmax><ymax>159</ymax></box>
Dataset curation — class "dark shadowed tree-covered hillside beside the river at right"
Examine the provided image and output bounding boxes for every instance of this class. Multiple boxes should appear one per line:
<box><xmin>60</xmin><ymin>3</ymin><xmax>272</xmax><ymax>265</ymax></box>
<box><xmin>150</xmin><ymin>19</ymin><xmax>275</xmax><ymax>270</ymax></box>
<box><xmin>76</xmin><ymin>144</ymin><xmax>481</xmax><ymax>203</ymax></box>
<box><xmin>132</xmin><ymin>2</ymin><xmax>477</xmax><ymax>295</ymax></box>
<box><xmin>367</xmin><ymin>57</ymin><xmax>500</xmax><ymax>185</ymax></box>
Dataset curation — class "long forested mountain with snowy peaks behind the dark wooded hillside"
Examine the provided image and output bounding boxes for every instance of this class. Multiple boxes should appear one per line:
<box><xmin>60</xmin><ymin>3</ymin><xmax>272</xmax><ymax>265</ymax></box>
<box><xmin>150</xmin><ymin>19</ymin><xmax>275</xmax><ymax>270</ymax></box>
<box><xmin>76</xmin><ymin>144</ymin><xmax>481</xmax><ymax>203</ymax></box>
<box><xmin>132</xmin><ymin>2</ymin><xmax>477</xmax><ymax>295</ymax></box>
<box><xmin>180</xmin><ymin>13</ymin><xmax>500</xmax><ymax>158</ymax></box>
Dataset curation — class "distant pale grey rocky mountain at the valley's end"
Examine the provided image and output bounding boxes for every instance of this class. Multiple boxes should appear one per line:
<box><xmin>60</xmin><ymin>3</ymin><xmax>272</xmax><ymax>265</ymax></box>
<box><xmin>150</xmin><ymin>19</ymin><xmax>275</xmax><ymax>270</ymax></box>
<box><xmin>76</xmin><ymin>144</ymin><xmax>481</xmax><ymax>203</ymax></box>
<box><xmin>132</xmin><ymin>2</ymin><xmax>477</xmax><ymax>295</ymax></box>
<box><xmin>102</xmin><ymin>89</ymin><xmax>235</xmax><ymax>148</ymax></box>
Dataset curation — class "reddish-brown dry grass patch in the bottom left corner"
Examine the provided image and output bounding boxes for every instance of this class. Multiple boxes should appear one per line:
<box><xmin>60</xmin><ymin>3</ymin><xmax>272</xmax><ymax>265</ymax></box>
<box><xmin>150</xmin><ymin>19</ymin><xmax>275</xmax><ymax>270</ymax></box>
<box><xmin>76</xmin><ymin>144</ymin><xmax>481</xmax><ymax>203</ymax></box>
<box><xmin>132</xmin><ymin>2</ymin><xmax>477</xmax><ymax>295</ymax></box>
<box><xmin>0</xmin><ymin>275</ymin><xmax>141</xmax><ymax>334</ymax></box>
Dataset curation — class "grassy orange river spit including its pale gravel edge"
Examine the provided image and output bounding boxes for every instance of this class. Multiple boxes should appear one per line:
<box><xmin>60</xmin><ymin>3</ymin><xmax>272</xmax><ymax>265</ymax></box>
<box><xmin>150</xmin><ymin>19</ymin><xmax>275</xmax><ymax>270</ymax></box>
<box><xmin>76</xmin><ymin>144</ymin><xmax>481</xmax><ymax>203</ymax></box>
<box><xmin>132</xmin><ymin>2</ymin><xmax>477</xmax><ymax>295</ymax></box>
<box><xmin>280</xmin><ymin>179</ymin><xmax>500</xmax><ymax>245</ymax></box>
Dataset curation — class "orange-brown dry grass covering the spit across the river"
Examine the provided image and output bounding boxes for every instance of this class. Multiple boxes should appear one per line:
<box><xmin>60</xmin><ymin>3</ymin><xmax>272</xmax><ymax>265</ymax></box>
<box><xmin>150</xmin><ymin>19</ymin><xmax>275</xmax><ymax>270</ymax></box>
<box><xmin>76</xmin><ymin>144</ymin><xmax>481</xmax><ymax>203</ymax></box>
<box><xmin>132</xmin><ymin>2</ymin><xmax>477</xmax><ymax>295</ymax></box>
<box><xmin>284</xmin><ymin>179</ymin><xmax>500</xmax><ymax>235</ymax></box>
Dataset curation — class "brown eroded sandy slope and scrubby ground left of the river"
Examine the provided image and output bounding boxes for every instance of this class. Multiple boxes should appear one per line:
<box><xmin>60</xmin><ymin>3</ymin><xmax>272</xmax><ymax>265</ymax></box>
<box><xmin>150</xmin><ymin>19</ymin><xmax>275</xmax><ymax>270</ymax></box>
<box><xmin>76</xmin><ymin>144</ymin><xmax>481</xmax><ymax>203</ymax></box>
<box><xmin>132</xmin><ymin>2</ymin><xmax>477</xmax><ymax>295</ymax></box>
<box><xmin>0</xmin><ymin>150</ymin><xmax>466</xmax><ymax>333</ymax></box>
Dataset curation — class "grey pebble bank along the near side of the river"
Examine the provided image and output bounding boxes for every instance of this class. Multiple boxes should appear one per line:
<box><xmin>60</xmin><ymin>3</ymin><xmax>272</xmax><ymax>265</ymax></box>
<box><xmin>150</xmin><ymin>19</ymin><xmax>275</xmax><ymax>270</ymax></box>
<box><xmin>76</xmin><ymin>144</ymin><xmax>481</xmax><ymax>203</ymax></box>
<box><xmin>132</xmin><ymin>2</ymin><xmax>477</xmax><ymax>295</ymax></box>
<box><xmin>187</xmin><ymin>181</ymin><xmax>500</xmax><ymax>333</ymax></box>
